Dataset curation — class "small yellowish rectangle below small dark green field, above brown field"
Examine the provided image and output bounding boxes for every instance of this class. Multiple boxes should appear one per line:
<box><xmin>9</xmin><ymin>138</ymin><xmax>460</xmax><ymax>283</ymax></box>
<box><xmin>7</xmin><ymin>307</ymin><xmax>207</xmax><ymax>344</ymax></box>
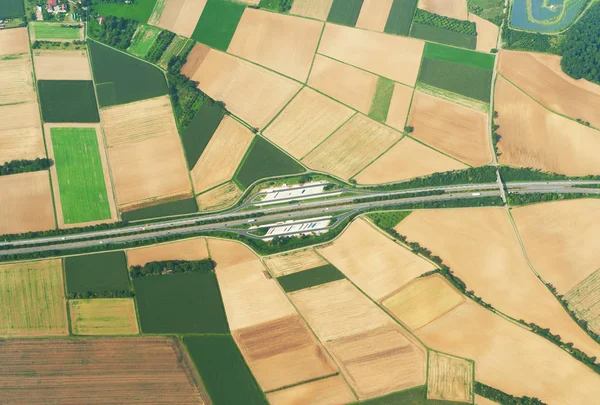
<box><xmin>69</xmin><ymin>298</ymin><xmax>139</xmax><ymax>336</ymax></box>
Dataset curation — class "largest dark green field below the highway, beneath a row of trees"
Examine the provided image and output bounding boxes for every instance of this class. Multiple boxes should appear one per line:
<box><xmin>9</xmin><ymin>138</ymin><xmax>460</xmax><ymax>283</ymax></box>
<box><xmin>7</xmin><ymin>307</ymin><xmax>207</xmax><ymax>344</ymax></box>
<box><xmin>133</xmin><ymin>271</ymin><xmax>229</xmax><ymax>333</ymax></box>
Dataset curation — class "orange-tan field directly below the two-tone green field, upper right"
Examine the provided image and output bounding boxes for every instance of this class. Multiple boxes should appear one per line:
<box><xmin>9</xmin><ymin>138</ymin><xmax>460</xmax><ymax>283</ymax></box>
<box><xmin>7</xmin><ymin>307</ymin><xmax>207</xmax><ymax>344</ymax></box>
<box><xmin>408</xmin><ymin>91</ymin><xmax>492</xmax><ymax>166</ymax></box>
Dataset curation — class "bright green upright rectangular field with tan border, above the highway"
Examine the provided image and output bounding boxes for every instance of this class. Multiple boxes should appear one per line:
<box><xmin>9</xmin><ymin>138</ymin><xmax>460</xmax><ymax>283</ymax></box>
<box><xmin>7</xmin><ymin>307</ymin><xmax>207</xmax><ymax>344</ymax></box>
<box><xmin>50</xmin><ymin>128</ymin><xmax>110</xmax><ymax>224</ymax></box>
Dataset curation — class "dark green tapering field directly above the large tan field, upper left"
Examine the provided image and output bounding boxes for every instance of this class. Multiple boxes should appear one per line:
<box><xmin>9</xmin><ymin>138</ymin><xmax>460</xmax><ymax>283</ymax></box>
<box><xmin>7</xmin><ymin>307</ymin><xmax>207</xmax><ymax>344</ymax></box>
<box><xmin>88</xmin><ymin>41</ymin><xmax>168</xmax><ymax>107</ymax></box>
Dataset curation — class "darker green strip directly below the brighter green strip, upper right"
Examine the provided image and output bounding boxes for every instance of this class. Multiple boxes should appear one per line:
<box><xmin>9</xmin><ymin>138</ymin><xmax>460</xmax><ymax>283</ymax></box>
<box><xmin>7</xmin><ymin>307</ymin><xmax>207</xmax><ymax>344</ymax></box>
<box><xmin>418</xmin><ymin>58</ymin><xmax>492</xmax><ymax>103</ymax></box>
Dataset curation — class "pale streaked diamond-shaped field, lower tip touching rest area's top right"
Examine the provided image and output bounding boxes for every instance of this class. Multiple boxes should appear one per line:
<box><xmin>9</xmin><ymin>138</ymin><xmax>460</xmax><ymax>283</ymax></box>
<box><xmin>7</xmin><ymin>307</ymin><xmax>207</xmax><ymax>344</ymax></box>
<box><xmin>302</xmin><ymin>114</ymin><xmax>402</xmax><ymax>180</ymax></box>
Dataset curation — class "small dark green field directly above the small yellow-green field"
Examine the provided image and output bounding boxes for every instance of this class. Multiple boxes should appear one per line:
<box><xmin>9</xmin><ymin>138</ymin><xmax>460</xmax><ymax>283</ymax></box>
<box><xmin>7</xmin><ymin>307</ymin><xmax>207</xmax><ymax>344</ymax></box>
<box><xmin>65</xmin><ymin>251</ymin><xmax>129</xmax><ymax>294</ymax></box>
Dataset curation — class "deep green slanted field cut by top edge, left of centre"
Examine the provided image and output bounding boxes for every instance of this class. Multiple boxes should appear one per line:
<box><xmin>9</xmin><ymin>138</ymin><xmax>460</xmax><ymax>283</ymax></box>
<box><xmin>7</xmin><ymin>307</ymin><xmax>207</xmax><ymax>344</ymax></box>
<box><xmin>192</xmin><ymin>0</ymin><xmax>246</xmax><ymax>51</ymax></box>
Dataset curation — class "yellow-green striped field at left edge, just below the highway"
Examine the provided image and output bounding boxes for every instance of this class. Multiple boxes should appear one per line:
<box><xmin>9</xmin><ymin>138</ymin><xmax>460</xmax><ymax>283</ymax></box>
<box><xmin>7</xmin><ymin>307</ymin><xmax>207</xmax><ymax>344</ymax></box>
<box><xmin>0</xmin><ymin>260</ymin><xmax>69</xmax><ymax>336</ymax></box>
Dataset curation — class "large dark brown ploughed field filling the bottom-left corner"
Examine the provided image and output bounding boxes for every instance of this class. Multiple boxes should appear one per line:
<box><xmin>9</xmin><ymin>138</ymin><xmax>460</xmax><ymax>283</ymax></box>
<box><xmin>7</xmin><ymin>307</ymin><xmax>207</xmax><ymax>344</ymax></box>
<box><xmin>0</xmin><ymin>337</ymin><xmax>207</xmax><ymax>405</ymax></box>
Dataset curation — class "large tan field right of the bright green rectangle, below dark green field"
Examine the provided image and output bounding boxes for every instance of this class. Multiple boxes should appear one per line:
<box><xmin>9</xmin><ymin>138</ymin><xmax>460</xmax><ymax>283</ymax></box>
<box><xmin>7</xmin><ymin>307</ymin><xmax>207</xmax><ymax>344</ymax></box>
<box><xmin>100</xmin><ymin>96</ymin><xmax>191</xmax><ymax>209</ymax></box>
